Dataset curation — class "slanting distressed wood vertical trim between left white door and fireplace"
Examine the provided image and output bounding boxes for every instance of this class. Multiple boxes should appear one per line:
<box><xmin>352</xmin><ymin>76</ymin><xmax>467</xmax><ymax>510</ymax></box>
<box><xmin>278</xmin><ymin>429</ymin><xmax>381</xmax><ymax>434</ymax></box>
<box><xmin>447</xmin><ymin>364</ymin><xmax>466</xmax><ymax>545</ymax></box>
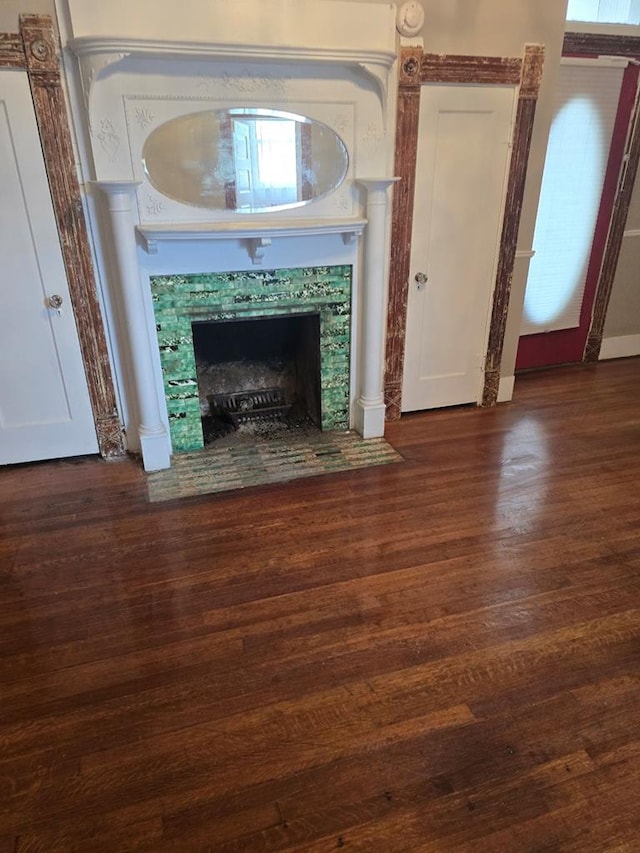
<box><xmin>20</xmin><ymin>15</ymin><xmax>125</xmax><ymax>459</ymax></box>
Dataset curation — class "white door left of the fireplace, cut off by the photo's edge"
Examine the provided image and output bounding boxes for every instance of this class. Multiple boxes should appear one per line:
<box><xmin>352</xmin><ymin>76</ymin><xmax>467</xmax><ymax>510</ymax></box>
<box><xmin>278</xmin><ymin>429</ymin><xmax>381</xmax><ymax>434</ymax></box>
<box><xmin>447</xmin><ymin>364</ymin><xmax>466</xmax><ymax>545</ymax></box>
<box><xmin>0</xmin><ymin>69</ymin><xmax>98</xmax><ymax>464</ymax></box>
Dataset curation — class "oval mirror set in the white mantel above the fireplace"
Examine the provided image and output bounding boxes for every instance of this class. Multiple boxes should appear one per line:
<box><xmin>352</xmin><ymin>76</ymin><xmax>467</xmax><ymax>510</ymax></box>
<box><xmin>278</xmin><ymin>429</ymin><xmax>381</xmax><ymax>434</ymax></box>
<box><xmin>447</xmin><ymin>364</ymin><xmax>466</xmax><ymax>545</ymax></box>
<box><xmin>142</xmin><ymin>107</ymin><xmax>349</xmax><ymax>213</ymax></box>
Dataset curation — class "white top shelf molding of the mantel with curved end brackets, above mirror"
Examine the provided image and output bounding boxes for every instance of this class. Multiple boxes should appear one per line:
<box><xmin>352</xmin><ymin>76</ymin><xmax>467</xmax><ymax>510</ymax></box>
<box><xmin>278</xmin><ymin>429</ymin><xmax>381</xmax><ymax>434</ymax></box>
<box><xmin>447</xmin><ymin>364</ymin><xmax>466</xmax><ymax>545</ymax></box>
<box><xmin>67</xmin><ymin>36</ymin><xmax>396</xmax><ymax>115</ymax></box>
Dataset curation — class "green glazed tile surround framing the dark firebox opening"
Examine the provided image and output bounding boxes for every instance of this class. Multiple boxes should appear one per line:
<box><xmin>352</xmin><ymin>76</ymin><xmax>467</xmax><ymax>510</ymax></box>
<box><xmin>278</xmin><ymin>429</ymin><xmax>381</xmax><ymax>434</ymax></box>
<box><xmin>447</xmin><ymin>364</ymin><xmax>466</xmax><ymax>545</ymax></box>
<box><xmin>150</xmin><ymin>265</ymin><xmax>352</xmax><ymax>453</ymax></box>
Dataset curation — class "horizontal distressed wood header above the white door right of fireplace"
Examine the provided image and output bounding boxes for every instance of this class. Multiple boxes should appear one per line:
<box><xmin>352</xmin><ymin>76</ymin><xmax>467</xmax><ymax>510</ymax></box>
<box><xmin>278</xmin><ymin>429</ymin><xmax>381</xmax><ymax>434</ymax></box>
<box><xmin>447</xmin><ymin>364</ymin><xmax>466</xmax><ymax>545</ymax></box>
<box><xmin>420</xmin><ymin>53</ymin><xmax>522</xmax><ymax>86</ymax></box>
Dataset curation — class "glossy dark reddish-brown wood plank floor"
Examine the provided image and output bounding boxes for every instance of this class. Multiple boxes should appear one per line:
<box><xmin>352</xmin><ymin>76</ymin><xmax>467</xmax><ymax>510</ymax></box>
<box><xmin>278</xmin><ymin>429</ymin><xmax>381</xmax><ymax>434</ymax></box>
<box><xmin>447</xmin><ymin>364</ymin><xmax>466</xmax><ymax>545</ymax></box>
<box><xmin>0</xmin><ymin>359</ymin><xmax>640</xmax><ymax>853</ymax></box>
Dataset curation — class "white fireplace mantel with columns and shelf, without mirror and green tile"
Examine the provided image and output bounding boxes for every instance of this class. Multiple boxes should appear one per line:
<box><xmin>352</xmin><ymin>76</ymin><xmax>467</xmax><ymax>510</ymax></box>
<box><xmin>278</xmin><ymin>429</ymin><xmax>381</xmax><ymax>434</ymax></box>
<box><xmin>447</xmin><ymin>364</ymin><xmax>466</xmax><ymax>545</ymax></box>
<box><xmin>66</xmin><ymin>0</ymin><xmax>397</xmax><ymax>470</ymax></box>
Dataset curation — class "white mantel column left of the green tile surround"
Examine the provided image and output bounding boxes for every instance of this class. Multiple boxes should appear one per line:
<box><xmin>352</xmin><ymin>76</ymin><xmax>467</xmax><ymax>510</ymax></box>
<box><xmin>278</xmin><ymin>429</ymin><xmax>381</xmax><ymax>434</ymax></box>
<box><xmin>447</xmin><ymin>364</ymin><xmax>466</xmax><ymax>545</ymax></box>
<box><xmin>96</xmin><ymin>181</ymin><xmax>171</xmax><ymax>471</ymax></box>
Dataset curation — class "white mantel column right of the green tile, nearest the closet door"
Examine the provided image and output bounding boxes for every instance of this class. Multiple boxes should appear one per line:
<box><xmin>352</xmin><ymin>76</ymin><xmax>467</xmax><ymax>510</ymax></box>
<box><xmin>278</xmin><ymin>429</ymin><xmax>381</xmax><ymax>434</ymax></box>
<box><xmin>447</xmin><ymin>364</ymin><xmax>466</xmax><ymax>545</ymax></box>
<box><xmin>355</xmin><ymin>178</ymin><xmax>400</xmax><ymax>438</ymax></box>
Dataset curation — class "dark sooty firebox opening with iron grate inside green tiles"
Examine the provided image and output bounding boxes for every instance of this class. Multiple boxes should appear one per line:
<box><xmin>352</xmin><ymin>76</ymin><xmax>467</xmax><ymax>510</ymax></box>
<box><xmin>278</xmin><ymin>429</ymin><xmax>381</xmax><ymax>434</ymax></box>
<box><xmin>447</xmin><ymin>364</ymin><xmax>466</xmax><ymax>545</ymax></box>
<box><xmin>192</xmin><ymin>314</ymin><xmax>322</xmax><ymax>446</ymax></box>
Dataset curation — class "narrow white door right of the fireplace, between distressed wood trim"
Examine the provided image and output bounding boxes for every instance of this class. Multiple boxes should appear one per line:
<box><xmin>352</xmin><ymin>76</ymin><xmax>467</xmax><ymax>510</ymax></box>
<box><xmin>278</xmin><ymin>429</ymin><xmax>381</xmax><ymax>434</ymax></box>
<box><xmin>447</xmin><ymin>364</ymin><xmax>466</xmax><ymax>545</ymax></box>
<box><xmin>402</xmin><ymin>85</ymin><xmax>515</xmax><ymax>412</ymax></box>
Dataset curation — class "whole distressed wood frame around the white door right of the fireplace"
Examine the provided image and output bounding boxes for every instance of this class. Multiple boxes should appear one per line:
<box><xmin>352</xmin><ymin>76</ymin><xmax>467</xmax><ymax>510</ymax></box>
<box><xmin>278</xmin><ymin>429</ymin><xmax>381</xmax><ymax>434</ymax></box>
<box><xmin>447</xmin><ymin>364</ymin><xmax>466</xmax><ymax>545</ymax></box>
<box><xmin>385</xmin><ymin>45</ymin><xmax>544</xmax><ymax>420</ymax></box>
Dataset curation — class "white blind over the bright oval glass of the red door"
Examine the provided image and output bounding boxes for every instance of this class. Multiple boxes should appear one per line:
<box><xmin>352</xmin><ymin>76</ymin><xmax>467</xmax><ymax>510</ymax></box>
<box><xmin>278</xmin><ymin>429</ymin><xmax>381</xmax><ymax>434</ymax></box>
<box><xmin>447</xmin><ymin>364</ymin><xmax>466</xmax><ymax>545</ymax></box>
<box><xmin>520</xmin><ymin>62</ymin><xmax>624</xmax><ymax>335</ymax></box>
